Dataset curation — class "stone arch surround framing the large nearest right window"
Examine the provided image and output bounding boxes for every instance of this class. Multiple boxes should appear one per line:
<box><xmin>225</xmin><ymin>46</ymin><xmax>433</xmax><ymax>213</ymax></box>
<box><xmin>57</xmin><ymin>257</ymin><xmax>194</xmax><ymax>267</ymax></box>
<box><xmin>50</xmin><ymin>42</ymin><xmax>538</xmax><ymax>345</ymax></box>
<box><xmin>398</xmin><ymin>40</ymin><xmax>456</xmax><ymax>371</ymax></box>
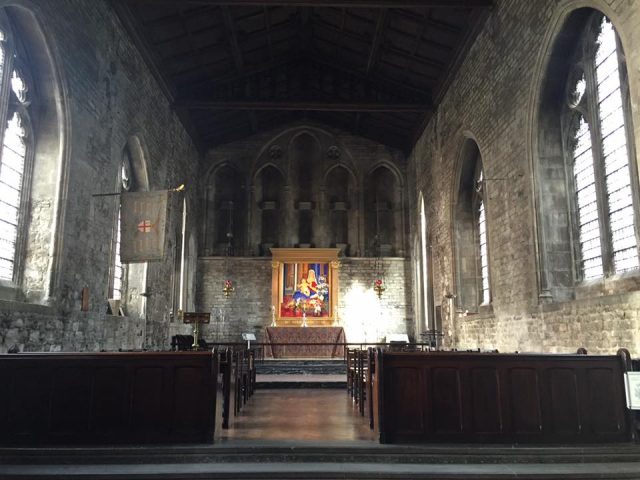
<box><xmin>527</xmin><ymin>0</ymin><xmax>639</xmax><ymax>302</ymax></box>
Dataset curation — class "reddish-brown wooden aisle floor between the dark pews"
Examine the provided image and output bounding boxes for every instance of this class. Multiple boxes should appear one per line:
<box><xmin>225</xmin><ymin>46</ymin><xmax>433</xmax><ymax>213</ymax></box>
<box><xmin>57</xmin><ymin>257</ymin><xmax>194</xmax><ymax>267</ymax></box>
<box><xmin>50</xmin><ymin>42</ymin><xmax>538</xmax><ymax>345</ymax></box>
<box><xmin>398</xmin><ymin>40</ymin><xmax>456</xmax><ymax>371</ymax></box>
<box><xmin>222</xmin><ymin>388</ymin><xmax>374</xmax><ymax>442</ymax></box>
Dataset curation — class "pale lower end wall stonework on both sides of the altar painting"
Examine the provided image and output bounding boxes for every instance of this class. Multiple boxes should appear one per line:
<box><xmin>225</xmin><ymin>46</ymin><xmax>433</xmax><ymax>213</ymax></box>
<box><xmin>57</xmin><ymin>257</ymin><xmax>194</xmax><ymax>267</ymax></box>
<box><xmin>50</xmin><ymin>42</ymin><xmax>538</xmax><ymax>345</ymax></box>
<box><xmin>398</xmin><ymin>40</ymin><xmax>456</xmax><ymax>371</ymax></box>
<box><xmin>194</xmin><ymin>257</ymin><xmax>414</xmax><ymax>342</ymax></box>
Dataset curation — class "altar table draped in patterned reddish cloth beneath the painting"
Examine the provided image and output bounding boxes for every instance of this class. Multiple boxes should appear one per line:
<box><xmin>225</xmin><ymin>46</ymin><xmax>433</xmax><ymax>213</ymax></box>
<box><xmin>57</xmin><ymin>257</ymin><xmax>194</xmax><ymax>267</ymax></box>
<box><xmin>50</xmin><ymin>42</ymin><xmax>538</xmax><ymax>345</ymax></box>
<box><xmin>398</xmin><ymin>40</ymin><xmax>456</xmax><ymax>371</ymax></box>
<box><xmin>266</xmin><ymin>327</ymin><xmax>345</xmax><ymax>358</ymax></box>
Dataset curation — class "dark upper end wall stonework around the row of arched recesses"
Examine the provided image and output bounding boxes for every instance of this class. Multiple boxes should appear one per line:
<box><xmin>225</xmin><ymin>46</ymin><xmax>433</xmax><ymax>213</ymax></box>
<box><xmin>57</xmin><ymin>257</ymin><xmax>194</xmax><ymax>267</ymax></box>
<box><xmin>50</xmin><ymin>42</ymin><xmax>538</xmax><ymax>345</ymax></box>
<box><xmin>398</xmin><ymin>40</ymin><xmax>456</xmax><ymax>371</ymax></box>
<box><xmin>200</xmin><ymin>122</ymin><xmax>408</xmax><ymax>257</ymax></box>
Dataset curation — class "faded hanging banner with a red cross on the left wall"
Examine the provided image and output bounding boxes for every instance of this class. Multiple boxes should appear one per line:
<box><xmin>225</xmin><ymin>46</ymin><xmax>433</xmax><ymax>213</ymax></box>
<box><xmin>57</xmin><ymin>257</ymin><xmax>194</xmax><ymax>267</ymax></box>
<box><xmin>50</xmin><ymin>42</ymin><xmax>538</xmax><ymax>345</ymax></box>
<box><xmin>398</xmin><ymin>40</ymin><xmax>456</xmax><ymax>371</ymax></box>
<box><xmin>120</xmin><ymin>190</ymin><xmax>169</xmax><ymax>263</ymax></box>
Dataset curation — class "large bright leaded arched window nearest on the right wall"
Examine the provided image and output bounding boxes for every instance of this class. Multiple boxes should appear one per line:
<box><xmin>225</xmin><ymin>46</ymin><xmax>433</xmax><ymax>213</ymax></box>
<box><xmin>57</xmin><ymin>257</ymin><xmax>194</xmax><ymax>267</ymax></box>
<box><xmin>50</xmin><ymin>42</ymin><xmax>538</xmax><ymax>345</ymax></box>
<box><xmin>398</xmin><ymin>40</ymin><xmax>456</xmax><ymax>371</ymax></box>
<box><xmin>562</xmin><ymin>12</ymin><xmax>639</xmax><ymax>280</ymax></box>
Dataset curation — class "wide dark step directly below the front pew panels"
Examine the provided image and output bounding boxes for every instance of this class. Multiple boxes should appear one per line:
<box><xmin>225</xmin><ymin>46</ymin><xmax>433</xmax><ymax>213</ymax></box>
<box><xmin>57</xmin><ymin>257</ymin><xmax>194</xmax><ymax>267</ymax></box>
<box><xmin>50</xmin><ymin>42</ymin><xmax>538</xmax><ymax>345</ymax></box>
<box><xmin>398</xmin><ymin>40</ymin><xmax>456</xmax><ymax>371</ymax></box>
<box><xmin>5</xmin><ymin>440</ymin><xmax>640</xmax><ymax>464</ymax></box>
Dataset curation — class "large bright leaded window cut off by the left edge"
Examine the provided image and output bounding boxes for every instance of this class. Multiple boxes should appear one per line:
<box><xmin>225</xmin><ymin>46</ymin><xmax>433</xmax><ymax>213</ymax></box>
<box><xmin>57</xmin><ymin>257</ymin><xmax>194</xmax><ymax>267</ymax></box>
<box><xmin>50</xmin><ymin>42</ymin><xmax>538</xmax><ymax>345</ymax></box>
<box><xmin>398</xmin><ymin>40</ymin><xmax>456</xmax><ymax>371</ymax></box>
<box><xmin>0</xmin><ymin>22</ymin><xmax>34</xmax><ymax>284</ymax></box>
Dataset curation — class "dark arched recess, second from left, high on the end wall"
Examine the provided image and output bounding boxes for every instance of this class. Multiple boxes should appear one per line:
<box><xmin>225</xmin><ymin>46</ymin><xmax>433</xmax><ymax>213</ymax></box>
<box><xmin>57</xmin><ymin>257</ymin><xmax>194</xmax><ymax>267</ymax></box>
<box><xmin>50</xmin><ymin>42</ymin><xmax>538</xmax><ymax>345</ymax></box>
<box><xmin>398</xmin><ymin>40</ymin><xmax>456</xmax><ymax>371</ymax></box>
<box><xmin>252</xmin><ymin>164</ymin><xmax>286</xmax><ymax>256</ymax></box>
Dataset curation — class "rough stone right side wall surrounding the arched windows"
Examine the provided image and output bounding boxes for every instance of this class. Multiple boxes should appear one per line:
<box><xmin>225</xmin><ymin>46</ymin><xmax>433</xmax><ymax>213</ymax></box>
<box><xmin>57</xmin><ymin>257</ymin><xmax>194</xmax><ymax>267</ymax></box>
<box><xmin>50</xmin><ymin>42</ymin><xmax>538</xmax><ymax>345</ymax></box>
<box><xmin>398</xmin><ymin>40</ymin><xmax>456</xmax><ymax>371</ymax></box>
<box><xmin>409</xmin><ymin>0</ymin><xmax>640</xmax><ymax>355</ymax></box>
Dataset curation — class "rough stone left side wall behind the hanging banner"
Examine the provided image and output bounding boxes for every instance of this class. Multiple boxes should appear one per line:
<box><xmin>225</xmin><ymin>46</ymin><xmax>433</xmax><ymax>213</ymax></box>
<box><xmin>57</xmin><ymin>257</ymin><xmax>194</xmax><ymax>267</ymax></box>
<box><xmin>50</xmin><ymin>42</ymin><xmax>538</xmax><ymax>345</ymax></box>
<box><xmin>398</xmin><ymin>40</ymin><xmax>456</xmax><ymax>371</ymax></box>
<box><xmin>0</xmin><ymin>0</ymin><xmax>199</xmax><ymax>352</ymax></box>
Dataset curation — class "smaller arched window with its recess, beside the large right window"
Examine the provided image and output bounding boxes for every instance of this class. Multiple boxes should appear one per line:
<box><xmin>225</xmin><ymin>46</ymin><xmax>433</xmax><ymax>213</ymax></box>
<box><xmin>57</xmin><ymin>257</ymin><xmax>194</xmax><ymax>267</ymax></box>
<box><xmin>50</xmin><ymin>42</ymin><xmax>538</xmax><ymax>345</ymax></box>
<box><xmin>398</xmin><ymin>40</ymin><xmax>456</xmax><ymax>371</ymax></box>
<box><xmin>453</xmin><ymin>138</ymin><xmax>491</xmax><ymax>312</ymax></box>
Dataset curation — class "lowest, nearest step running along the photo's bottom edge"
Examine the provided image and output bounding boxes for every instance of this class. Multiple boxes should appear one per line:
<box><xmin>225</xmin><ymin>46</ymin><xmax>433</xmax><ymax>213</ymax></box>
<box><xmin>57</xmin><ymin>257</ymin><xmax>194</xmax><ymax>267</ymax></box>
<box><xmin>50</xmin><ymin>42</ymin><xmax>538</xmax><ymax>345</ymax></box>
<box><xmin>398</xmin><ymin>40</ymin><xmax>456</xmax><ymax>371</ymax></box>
<box><xmin>0</xmin><ymin>462</ymin><xmax>640</xmax><ymax>480</ymax></box>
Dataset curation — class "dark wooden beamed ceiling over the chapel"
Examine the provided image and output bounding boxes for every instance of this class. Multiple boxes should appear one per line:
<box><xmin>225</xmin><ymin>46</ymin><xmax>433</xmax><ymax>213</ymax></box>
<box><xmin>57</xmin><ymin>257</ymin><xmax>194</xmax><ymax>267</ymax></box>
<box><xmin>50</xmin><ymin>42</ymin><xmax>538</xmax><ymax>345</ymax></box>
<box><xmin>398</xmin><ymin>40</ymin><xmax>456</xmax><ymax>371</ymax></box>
<box><xmin>109</xmin><ymin>0</ymin><xmax>494</xmax><ymax>152</ymax></box>
